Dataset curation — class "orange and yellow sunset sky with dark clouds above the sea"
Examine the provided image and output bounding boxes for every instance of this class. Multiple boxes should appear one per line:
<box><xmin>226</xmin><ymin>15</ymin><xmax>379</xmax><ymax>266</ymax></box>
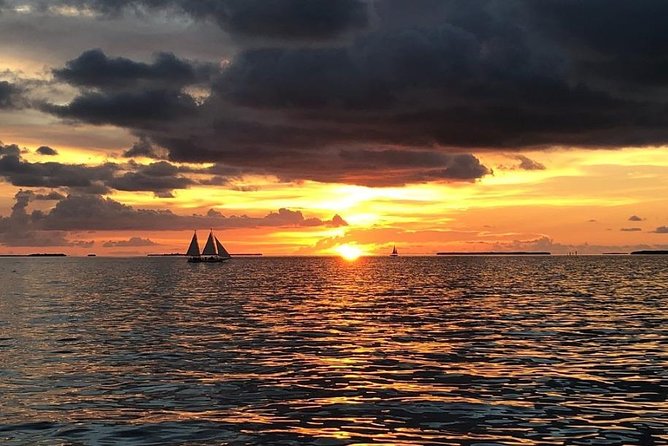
<box><xmin>0</xmin><ymin>0</ymin><xmax>668</xmax><ymax>256</ymax></box>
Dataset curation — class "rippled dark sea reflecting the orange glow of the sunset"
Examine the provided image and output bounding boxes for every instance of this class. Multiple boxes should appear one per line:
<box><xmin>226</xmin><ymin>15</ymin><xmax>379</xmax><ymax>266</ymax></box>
<box><xmin>0</xmin><ymin>256</ymin><xmax>668</xmax><ymax>446</ymax></box>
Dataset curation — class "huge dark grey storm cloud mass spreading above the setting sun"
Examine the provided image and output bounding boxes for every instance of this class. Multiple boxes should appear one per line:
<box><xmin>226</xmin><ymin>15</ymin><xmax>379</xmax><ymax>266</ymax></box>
<box><xmin>22</xmin><ymin>0</ymin><xmax>668</xmax><ymax>184</ymax></box>
